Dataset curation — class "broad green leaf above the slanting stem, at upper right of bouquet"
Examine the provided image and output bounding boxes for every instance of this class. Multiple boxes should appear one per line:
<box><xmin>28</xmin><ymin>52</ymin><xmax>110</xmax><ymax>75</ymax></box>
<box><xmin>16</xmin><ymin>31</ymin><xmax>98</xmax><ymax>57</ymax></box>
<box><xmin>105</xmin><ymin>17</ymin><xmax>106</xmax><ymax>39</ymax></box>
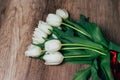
<box><xmin>78</xmin><ymin>22</ymin><xmax>108</xmax><ymax>47</ymax></box>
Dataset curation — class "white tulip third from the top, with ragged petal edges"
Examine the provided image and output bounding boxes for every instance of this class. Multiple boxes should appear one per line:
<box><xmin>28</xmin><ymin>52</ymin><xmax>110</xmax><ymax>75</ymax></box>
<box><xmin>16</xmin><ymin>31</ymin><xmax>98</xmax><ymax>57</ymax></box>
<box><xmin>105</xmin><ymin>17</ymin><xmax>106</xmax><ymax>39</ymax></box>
<box><xmin>38</xmin><ymin>21</ymin><xmax>53</xmax><ymax>34</ymax></box>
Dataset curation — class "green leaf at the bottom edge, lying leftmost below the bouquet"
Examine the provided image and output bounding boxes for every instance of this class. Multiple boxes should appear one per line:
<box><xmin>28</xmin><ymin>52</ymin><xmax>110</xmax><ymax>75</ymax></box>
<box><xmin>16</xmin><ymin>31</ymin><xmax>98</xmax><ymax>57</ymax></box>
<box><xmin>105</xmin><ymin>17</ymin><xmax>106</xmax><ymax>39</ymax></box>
<box><xmin>73</xmin><ymin>67</ymin><xmax>91</xmax><ymax>80</ymax></box>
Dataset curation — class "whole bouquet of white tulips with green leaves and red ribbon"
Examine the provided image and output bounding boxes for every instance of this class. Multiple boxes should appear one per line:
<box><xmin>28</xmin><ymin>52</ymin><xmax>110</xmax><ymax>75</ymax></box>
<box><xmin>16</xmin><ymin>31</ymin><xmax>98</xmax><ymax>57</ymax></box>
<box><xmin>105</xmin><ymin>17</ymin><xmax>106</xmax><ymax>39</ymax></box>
<box><xmin>25</xmin><ymin>9</ymin><xmax>120</xmax><ymax>80</ymax></box>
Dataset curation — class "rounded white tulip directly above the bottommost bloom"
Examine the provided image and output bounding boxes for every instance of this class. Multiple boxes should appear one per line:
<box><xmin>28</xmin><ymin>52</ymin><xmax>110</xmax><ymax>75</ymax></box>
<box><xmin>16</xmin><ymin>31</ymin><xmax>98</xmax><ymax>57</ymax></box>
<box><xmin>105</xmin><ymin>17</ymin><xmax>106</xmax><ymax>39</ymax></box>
<box><xmin>45</xmin><ymin>39</ymin><xmax>62</xmax><ymax>52</ymax></box>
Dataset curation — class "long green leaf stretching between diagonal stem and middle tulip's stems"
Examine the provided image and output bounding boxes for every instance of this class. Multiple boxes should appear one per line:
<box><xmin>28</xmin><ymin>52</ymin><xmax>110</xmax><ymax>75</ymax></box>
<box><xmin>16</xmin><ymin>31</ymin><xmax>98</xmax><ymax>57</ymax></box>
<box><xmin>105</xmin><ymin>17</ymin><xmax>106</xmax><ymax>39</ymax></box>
<box><xmin>53</xmin><ymin>28</ymin><xmax>106</xmax><ymax>53</ymax></box>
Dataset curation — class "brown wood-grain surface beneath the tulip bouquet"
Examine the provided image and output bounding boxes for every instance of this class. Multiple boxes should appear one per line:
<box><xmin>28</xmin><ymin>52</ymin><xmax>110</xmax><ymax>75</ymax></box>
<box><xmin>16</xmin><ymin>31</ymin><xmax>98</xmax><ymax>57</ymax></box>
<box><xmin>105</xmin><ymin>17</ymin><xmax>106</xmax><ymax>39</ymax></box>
<box><xmin>0</xmin><ymin>0</ymin><xmax>120</xmax><ymax>80</ymax></box>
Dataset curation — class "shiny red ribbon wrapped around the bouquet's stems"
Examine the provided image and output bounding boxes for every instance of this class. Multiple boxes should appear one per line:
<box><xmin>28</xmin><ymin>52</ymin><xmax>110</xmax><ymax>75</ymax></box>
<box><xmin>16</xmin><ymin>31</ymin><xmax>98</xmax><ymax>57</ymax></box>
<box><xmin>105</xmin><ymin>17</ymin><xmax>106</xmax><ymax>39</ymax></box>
<box><xmin>110</xmin><ymin>50</ymin><xmax>120</xmax><ymax>80</ymax></box>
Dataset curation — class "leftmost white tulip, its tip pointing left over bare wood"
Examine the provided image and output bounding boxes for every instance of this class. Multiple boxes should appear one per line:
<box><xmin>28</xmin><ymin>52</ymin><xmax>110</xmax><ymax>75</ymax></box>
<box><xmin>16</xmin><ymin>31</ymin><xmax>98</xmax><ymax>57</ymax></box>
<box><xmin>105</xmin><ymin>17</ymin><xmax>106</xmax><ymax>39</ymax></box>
<box><xmin>25</xmin><ymin>44</ymin><xmax>42</xmax><ymax>57</ymax></box>
